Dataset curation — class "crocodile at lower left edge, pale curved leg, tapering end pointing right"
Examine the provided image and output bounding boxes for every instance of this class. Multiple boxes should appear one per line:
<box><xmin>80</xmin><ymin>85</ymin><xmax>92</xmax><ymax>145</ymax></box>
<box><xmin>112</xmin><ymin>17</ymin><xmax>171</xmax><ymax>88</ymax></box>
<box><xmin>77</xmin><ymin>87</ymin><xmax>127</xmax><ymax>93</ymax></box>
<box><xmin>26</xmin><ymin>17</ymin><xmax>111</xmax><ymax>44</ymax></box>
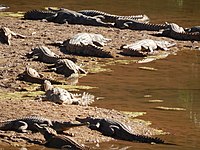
<box><xmin>0</xmin><ymin>116</ymin><xmax>88</xmax><ymax>133</ymax></box>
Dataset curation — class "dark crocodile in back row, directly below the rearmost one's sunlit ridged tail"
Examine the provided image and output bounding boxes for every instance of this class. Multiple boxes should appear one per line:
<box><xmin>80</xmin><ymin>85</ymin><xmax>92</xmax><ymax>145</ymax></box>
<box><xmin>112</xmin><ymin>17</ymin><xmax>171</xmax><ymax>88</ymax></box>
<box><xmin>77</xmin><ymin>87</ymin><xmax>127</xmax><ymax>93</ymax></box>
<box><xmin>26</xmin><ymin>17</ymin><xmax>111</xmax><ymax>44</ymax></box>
<box><xmin>114</xmin><ymin>18</ymin><xmax>168</xmax><ymax>31</ymax></box>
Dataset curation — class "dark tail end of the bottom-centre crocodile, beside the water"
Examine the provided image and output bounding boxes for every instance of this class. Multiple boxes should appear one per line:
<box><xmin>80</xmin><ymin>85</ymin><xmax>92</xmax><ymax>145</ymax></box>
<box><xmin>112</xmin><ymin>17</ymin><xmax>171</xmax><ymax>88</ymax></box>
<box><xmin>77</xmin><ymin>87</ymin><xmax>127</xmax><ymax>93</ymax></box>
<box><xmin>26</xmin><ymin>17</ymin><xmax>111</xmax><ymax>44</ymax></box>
<box><xmin>133</xmin><ymin>135</ymin><xmax>165</xmax><ymax>144</ymax></box>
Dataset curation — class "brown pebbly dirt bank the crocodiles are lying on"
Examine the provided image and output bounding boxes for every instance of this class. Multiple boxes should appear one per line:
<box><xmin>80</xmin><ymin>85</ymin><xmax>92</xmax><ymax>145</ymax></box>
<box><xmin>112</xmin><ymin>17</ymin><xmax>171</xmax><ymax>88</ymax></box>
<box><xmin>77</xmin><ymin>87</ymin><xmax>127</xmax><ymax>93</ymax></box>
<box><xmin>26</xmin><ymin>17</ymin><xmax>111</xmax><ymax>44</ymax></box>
<box><xmin>0</xmin><ymin>17</ymin><xmax>199</xmax><ymax>147</ymax></box>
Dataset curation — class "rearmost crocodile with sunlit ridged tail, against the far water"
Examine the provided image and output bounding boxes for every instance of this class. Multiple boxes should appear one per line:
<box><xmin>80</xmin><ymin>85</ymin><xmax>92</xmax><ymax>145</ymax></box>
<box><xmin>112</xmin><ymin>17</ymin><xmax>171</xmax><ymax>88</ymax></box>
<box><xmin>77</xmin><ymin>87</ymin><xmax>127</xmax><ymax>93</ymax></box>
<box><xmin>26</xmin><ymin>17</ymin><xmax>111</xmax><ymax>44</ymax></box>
<box><xmin>78</xmin><ymin>10</ymin><xmax>149</xmax><ymax>23</ymax></box>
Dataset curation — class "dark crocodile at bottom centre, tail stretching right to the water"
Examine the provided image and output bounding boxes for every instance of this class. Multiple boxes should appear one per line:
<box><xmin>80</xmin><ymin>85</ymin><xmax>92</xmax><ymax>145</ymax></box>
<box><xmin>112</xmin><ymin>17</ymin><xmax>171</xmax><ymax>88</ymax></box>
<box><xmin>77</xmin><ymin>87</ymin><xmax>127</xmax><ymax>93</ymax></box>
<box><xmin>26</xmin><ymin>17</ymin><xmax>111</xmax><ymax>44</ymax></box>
<box><xmin>76</xmin><ymin>117</ymin><xmax>164</xmax><ymax>144</ymax></box>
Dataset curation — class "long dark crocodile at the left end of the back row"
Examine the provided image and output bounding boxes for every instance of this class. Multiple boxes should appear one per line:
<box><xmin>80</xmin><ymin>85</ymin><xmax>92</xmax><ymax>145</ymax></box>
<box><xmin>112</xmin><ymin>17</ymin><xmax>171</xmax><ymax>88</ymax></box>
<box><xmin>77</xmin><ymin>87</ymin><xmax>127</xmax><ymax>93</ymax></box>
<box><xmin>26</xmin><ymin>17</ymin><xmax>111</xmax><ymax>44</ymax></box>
<box><xmin>24</xmin><ymin>8</ymin><xmax>113</xmax><ymax>27</ymax></box>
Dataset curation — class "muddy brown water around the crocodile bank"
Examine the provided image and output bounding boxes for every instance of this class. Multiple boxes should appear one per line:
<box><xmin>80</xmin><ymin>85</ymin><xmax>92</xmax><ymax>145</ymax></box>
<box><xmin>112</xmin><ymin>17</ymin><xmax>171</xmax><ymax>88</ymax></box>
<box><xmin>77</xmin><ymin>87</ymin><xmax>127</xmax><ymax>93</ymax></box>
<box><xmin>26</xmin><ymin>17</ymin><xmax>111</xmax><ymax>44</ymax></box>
<box><xmin>0</xmin><ymin>0</ymin><xmax>200</xmax><ymax>150</ymax></box>
